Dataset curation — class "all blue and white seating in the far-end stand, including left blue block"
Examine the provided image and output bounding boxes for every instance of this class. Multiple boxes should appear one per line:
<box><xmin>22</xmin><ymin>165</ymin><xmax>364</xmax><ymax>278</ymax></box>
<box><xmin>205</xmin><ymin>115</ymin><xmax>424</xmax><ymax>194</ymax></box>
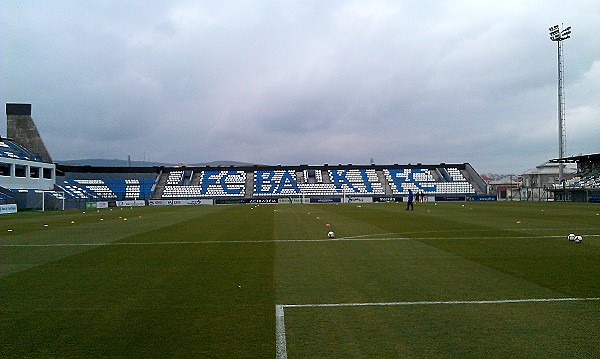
<box><xmin>59</xmin><ymin>167</ymin><xmax>482</xmax><ymax>200</ymax></box>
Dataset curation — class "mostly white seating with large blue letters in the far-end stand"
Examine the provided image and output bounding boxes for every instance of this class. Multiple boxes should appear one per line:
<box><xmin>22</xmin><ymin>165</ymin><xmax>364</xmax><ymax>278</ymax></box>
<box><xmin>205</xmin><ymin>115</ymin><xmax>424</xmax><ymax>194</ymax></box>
<box><xmin>156</xmin><ymin>167</ymin><xmax>482</xmax><ymax>198</ymax></box>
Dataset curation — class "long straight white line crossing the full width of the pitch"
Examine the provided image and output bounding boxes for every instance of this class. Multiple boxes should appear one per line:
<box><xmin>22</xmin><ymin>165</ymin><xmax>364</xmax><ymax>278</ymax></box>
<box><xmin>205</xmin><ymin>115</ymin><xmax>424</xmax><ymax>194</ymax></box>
<box><xmin>0</xmin><ymin>234</ymin><xmax>600</xmax><ymax>247</ymax></box>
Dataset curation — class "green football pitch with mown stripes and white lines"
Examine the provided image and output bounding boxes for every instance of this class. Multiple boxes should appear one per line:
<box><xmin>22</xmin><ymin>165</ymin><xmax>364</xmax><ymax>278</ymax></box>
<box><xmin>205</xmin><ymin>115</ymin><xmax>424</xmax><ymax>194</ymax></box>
<box><xmin>0</xmin><ymin>202</ymin><xmax>600</xmax><ymax>358</ymax></box>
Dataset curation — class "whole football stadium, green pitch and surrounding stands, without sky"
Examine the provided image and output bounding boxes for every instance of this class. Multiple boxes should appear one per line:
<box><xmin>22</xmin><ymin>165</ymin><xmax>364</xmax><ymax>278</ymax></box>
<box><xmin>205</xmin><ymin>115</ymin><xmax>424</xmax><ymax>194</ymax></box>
<box><xmin>0</xmin><ymin>104</ymin><xmax>600</xmax><ymax>358</ymax></box>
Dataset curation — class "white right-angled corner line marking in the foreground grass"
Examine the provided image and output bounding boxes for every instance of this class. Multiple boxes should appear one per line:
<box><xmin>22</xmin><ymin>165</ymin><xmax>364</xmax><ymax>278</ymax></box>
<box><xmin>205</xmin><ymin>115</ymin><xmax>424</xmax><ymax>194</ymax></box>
<box><xmin>275</xmin><ymin>297</ymin><xmax>600</xmax><ymax>359</ymax></box>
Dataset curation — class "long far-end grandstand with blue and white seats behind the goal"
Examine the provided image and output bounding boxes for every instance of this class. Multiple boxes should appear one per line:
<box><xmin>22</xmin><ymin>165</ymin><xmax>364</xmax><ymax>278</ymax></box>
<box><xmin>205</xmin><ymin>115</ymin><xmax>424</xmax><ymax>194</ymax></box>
<box><xmin>50</xmin><ymin>163</ymin><xmax>485</xmax><ymax>208</ymax></box>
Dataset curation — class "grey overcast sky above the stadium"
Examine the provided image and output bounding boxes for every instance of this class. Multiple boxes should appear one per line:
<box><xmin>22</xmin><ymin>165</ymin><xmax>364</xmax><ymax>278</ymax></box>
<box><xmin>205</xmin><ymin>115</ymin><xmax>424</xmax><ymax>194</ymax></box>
<box><xmin>0</xmin><ymin>0</ymin><xmax>600</xmax><ymax>173</ymax></box>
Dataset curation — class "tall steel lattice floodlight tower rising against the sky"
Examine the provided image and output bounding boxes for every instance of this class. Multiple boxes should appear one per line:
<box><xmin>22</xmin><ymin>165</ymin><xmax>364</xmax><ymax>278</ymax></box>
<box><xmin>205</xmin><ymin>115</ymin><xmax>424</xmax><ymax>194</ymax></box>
<box><xmin>548</xmin><ymin>25</ymin><xmax>571</xmax><ymax>183</ymax></box>
